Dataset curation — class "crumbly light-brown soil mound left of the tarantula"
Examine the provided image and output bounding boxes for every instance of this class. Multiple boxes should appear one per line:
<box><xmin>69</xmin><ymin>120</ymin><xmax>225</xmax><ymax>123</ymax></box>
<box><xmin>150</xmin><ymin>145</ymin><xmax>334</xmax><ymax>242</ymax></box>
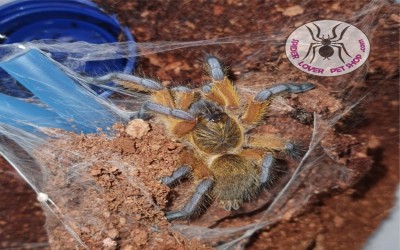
<box><xmin>40</xmin><ymin>120</ymin><xmax>206</xmax><ymax>250</ymax></box>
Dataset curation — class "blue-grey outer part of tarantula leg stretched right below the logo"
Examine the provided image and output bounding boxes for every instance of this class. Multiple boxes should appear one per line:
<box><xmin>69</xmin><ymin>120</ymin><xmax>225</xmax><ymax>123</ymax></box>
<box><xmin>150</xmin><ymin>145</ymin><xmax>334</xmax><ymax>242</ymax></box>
<box><xmin>254</xmin><ymin>83</ymin><xmax>315</xmax><ymax>102</ymax></box>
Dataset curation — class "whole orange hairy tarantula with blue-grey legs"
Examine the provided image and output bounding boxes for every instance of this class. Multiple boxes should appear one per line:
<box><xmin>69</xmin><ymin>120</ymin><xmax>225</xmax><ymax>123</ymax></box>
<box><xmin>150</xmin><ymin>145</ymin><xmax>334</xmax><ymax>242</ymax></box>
<box><xmin>94</xmin><ymin>56</ymin><xmax>314</xmax><ymax>220</ymax></box>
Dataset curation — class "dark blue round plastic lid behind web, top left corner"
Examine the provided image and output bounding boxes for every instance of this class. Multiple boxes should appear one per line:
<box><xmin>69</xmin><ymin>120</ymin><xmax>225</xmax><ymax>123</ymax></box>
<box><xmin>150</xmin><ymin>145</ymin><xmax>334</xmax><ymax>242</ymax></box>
<box><xmin>0</xmin><ymin>0</ymin><xmax>135</xmax><ymax>97</ymax></box>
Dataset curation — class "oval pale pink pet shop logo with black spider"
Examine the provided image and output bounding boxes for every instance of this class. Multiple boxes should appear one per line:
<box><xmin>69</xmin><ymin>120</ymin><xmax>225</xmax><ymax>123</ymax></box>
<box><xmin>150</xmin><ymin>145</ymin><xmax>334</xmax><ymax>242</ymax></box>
<box><xmin>286</xmin><ymin>20</ymin><xmax>371</xmax><ymax>76</ymax></box>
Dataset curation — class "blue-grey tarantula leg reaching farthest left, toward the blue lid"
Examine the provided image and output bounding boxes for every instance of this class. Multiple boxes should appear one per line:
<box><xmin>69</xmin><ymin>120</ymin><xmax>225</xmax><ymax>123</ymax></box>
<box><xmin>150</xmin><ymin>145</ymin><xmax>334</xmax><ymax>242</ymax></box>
<box><xmin>87</xmin><ymin>73</ymin><xmax>164</xmax><ymax>91</ymax></box>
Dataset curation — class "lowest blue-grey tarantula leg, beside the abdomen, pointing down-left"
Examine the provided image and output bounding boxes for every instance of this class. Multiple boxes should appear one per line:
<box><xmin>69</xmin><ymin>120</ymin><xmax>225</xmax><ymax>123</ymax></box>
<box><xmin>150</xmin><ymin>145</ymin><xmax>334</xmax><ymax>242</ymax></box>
<box><xmin>165</xmin><ymin>179</ymin><xmax>214</xmax><ymax>221</ymax></box>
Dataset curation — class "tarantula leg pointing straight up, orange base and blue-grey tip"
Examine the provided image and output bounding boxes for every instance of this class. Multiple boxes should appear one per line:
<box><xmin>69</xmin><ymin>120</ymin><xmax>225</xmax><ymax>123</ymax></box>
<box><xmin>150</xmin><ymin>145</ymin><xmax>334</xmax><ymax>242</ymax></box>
<box><xmin>202</xmin><ymin>56</ymin><xmax>240</xmax><ymax>109</ymax></box>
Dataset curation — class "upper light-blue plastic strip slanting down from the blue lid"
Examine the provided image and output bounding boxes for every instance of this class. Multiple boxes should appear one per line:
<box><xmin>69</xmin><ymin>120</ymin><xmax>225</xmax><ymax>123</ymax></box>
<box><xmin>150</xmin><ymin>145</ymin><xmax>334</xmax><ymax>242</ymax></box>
<box><xmin>0</xmin><ymin>49</ymin><xmax>118</xmax><ymax>133</ymax></box>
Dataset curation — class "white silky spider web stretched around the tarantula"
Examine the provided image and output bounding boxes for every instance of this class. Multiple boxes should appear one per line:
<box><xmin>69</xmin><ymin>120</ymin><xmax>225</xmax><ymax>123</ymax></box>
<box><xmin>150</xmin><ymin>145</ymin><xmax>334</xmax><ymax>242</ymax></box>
<box><xmin>0</xmin><ymin>1</ymin><xmax>394</xmax><ymax>249</ymax></box>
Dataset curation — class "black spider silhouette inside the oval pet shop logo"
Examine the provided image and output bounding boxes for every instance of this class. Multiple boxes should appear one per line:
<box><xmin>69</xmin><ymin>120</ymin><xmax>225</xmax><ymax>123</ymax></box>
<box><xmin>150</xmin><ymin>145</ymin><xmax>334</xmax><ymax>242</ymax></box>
<box><xmin>303</xmin><ymin>23</ymin><xmax>351</xmax><ymax>63</ymax></box>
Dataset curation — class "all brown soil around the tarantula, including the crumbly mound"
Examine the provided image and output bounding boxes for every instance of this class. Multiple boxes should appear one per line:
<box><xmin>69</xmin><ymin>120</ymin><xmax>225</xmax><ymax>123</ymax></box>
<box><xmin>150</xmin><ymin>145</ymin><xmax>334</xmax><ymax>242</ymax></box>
<box><xmin>0</xmin><ymin>0</ymin><xmax>400</xmax><ymax>249</ymax></box>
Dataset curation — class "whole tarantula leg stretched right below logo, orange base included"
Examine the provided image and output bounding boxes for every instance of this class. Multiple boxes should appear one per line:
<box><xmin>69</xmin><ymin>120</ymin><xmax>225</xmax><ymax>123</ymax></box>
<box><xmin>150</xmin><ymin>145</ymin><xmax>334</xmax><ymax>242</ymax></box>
<box><xmin>240</xmin><ymin>83</ymin><xmax>315</xmax><ymax>125</ymax></box>
